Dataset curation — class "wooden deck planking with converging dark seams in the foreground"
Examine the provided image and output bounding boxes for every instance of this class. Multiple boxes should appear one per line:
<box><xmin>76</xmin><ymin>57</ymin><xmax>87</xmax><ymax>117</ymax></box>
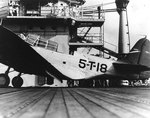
<box><xmin>0</xmin><ymin>88</ymin><xmax>150</xmax><ymax>118</ymax></box>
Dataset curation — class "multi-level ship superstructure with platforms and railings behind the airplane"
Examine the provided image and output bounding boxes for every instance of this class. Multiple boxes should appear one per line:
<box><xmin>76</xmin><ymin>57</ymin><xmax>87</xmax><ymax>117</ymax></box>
<box><xmin>0</xmin><ymin>0</ymin><xmax>130</xmax><ymax>85</ymax></box>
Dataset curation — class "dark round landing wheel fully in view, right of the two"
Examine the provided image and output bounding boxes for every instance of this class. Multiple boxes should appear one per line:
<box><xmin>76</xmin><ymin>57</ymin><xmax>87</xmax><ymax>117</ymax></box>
<box><xmin>12</xmin><ymin>76</ymin><xmax>23</xmax><ymax>88</ymax></box>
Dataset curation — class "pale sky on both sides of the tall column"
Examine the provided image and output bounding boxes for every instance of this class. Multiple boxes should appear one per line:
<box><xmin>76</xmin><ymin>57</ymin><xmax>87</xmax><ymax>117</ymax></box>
<box><xmin>82</xmin><ymin>0</ymin><xmax>150</xmax><ymax>47</ymax></box>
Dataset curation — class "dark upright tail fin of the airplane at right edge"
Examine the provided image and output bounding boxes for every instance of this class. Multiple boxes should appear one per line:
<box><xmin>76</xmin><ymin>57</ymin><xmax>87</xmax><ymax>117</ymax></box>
<box><xmin>125</xmin><ymin>38</ymin><xmax>150</xmax><ymax>67</ymax></box>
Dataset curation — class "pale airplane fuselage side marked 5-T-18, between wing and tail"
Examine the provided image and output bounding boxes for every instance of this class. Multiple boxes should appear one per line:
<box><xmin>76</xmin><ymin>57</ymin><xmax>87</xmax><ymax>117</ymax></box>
<box><xmin>33</xmin><ymin>47</ymin><xmax>114</xmax><ymax>79</ymax></box>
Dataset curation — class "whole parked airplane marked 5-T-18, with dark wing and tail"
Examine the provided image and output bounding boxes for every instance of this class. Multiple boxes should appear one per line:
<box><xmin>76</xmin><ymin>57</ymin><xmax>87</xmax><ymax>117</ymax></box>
<box><xmin>0</xmin><ymin>26</ymin><xmax>150</xmax><ymax>87</ymax></box>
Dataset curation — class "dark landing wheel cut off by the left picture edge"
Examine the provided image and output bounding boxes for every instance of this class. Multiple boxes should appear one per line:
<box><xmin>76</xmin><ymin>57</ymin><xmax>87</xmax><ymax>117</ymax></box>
<box><xmin>0</xmin><ymin>74</ymin><xmax>10</xmax><ymax>87</ymax></box>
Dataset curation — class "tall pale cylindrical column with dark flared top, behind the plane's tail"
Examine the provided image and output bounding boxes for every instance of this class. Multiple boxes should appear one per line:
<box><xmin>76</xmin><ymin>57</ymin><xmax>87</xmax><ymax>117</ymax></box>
<box><xmin>116</xmin><ymin>0</ymin><xmax>129</xmax><ymax>54</ymax></box>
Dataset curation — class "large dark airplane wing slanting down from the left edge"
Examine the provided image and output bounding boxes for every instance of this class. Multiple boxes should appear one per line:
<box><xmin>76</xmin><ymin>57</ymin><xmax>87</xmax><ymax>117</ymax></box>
<box><xmin>0</xmin><ymin>26</ymin><xmax>69</xmax><ymax>79</ymax></box>
